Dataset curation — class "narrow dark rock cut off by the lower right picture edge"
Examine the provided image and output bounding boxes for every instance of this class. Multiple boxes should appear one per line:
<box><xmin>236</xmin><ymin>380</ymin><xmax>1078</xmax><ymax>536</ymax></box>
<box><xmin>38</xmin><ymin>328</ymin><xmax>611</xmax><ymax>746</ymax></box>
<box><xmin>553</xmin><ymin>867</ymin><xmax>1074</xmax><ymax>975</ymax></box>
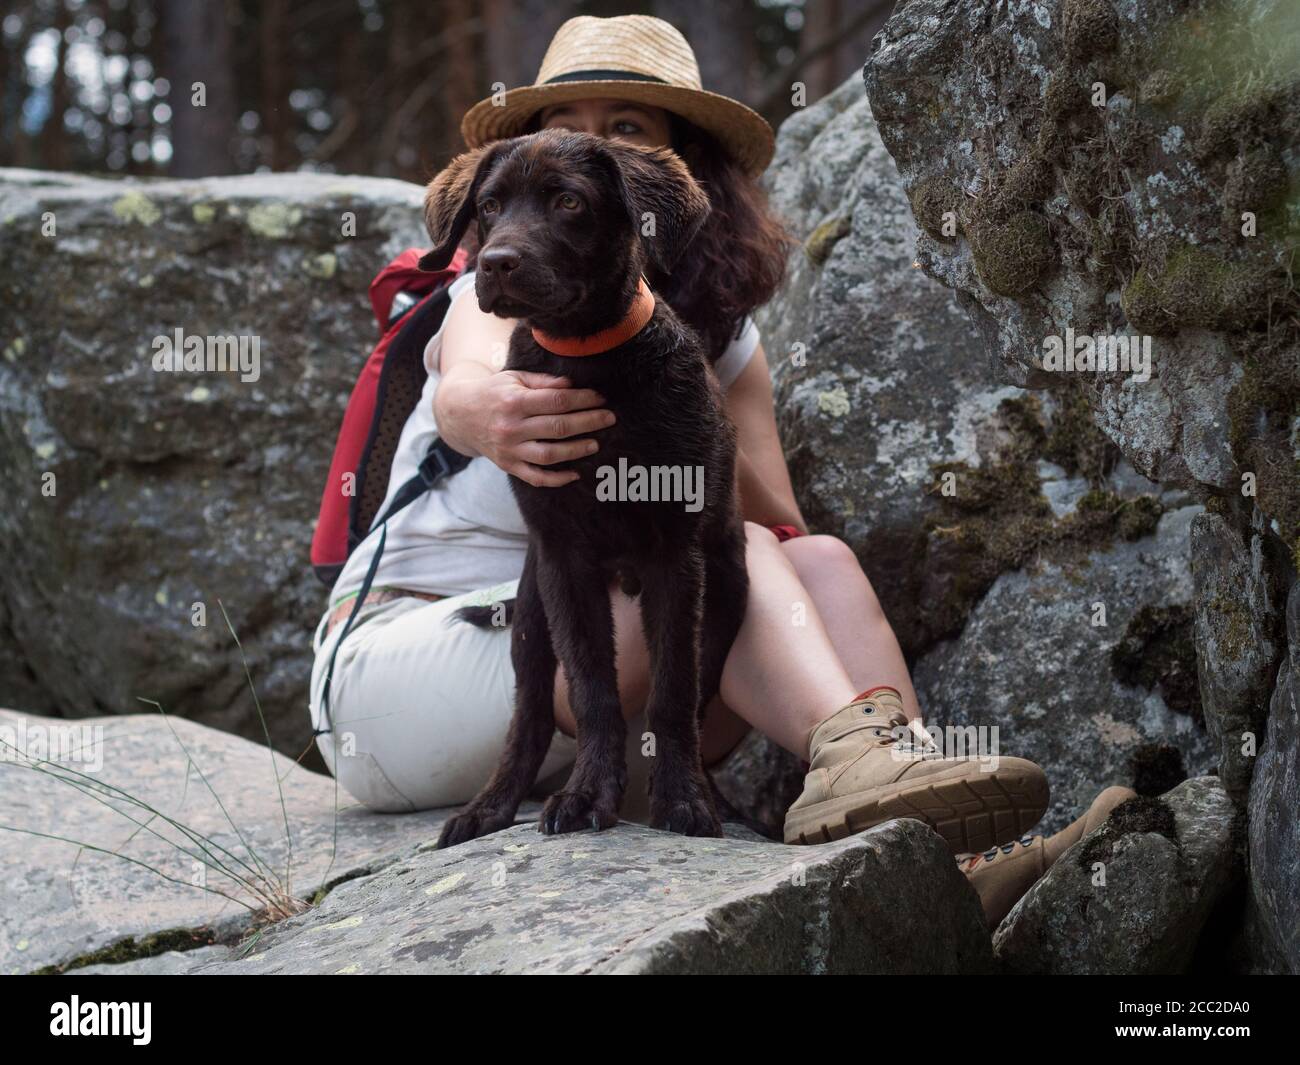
<box><xmin>1249</xmin><ymin>583</ymin><xmax>1300</xmax><ymax>973</ymax></box>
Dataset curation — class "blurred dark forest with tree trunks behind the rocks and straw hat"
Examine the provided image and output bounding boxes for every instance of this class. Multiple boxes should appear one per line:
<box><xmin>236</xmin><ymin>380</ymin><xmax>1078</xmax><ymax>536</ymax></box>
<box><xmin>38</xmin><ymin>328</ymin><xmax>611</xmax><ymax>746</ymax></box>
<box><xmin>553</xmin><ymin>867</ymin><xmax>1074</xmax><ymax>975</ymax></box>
<box><xmin>0</xmin><ymin>0</ymin><xmax>893</xmax><ymax>181</ymax></box>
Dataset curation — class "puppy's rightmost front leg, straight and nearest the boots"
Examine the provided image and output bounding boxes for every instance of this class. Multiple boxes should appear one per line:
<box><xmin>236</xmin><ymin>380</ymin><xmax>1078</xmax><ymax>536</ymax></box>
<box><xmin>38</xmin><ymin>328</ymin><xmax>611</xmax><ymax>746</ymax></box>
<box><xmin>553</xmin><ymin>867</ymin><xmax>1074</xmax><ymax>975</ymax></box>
<box><xmin>641</xmin><ymin>546</ymin><xmax>723</xmax><ymax>836</ymax></box>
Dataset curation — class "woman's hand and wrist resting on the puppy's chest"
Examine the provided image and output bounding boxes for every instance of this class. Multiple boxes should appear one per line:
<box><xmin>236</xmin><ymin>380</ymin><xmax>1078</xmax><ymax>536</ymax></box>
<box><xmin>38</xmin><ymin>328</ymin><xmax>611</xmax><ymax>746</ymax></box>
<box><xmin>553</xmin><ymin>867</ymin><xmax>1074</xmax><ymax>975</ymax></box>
<box><xmin>433</xmin><ymin>362</ymin><xmax>615</xmax><ymax>488</ymax></box>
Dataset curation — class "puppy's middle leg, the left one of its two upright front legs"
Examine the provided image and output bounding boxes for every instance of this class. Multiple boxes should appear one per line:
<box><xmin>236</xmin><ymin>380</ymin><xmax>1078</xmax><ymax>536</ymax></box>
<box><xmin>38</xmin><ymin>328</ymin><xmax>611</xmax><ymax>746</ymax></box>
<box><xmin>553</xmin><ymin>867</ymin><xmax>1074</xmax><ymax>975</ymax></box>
<box><xmin>538</xmin><ymin>544</ymin><xmax>628</xmax><ymax>835</ymax></box>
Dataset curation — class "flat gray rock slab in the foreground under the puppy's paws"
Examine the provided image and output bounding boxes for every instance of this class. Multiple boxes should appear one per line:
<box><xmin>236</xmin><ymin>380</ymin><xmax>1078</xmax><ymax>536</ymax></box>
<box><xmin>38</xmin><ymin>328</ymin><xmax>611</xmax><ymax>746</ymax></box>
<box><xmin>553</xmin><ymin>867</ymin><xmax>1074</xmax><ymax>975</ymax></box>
<box><xmin>180</xmin><ymin>821</ymin><xmax>992</xmax><ymax>974</ymax></box>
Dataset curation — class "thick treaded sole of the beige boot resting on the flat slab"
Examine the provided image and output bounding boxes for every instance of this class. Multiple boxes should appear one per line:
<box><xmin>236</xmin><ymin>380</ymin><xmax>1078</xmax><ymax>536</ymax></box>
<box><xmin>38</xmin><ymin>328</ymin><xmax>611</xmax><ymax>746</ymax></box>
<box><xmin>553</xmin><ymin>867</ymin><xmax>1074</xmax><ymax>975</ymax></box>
<box><xmin>785</xmin><ymin>767</ymin><xmax>1049</xmax><ymax>854</ymax></box>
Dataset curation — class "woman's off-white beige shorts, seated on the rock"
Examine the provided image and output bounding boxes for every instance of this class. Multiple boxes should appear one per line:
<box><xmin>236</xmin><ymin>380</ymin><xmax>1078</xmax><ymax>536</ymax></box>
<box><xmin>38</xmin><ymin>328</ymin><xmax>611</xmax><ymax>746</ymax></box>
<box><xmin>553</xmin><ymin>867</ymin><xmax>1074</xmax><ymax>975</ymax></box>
<box><xmin>311</xmin><ymin>581</ymin><xmax>576</xmax><ymax>813</ymax></box>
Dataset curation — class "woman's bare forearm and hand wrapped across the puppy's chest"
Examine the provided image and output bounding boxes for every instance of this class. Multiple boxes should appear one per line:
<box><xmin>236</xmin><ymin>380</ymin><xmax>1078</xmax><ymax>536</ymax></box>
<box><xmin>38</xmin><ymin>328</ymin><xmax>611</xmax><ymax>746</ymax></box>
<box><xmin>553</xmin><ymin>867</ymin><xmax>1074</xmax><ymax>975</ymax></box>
<box><xmin>433</xmin><ymin>296</ymin><xmax>614</xmax><ymax>488</ymax></box>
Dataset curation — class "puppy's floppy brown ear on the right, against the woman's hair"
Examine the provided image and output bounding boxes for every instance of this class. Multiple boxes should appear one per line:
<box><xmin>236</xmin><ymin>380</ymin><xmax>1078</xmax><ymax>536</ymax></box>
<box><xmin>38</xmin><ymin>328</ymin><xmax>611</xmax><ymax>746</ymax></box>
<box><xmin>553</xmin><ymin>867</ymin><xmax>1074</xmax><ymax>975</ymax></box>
<box><xmin>601</xmin><ymin>140</ymin><xmax>711</xmax><ymax>273</ymax></box>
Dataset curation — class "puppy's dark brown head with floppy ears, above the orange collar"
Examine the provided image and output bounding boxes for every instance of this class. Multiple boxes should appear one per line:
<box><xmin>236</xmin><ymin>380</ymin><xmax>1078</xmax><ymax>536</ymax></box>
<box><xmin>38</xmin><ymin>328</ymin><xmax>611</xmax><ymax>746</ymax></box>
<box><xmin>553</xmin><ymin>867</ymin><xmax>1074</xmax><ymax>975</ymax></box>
<box><xmin>420</xmin><ymin>130</ymin><xmax>709</xmax><ymax>322</ymax></box>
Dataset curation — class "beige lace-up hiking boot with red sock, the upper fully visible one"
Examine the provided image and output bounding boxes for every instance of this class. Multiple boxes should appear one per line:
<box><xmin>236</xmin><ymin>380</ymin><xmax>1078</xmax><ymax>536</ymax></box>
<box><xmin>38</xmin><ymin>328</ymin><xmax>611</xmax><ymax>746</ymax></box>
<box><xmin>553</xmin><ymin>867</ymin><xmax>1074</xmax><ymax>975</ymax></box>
<box><xmin>785</xmin><ymin>688</ymin><xmax>1048</xmax><ymax>854</ymax></box>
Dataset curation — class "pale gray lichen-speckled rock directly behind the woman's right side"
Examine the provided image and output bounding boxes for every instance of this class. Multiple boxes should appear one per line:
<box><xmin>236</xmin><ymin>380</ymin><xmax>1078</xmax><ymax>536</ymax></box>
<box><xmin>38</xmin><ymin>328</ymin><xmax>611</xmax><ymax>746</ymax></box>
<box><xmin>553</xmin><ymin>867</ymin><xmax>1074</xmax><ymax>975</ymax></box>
<box><xmin>755</xmin><ymin>77</ymin><xmax>1019</xmax><ymax>651</ymax></box>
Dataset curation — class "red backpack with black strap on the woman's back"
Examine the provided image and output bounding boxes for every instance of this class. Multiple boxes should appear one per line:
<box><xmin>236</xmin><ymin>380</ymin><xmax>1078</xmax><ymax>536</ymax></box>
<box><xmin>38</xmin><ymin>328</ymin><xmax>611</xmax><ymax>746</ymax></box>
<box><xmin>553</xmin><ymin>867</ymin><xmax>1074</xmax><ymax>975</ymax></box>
<box><xmin>312</xmin><ymin>248</ymin><xmax>468</xmax><ymax>585</ymax></box>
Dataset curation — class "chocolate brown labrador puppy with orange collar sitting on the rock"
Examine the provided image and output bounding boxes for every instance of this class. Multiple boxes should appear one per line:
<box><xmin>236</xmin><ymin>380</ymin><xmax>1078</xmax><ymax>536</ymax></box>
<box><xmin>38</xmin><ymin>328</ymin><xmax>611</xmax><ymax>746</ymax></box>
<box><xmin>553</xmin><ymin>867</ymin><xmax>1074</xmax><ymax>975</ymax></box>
<box><xmin>421</xmin><ymin>130</ymin><xmax>749</xmax><ymax>847</ymax></box>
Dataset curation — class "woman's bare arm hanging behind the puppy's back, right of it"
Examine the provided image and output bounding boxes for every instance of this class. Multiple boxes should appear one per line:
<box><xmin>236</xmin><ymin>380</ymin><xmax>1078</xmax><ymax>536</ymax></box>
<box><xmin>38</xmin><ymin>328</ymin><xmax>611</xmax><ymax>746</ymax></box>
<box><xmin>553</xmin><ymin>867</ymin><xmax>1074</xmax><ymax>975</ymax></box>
<box><xmin>727</xmin><ymin>345</ymin><xmax>807</xmax><ymax>533</ymax></box>
